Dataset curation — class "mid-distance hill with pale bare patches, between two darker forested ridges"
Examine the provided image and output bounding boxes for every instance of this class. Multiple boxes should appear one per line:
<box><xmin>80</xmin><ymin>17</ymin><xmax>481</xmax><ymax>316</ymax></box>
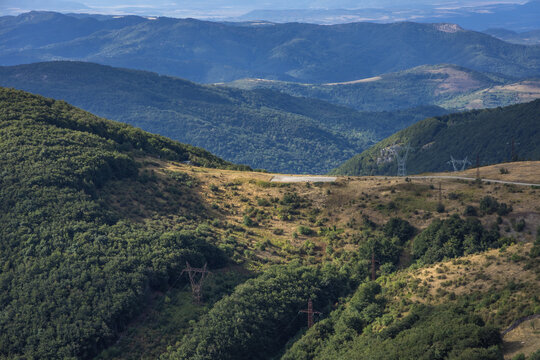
<box><xmin>225</xmin><ymin>64</ymin><xmax>508</xmax><ymax>111</ymax></box>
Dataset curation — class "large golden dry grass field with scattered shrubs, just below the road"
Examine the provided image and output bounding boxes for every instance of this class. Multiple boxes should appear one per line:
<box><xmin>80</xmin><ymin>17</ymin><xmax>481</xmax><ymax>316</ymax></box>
<box><xmin>115</xmin><ymin>159</ymin><xmax>540</xmax><ymax>268</ymax></box>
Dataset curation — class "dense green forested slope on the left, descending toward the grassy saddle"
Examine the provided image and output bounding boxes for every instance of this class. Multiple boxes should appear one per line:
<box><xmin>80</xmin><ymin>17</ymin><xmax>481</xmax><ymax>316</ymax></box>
<box><xmin>0</xmin><ymin>88</ymin><xmax>243</xmax><ymax>359</ymax></box>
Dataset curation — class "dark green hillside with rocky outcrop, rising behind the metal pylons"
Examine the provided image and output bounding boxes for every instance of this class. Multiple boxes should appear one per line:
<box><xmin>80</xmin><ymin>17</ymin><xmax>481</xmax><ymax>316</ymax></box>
<box><xmin>332</xmin><ymin>100</ymin><xmax>540</xmax><ymax>175</ymax></box>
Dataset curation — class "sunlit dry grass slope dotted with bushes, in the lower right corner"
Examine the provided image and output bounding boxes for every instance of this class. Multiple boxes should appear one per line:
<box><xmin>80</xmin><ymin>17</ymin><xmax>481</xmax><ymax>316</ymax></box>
<box><xmin>378</xmin><ymin>243</ymin><xmax>540</xmax><ymax>359</ymax></box>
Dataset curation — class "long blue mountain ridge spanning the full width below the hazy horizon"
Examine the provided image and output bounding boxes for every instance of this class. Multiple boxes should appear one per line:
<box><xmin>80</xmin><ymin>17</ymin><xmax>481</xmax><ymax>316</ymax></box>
<box><xmin>0</xmin><ymin>12</ymin><xmax>540</xmax><ymax>83</ymax></box>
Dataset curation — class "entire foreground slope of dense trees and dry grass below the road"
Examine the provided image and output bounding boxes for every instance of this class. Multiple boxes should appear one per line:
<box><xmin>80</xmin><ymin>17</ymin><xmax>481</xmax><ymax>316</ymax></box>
<box><xmin>0</xmin><ymin>89</ymin><xmax>540</xmax><ymax>359</ymax></box>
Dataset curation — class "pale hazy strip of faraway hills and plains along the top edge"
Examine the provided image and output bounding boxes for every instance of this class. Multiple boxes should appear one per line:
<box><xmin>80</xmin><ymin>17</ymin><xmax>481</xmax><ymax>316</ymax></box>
<box><xmin>0</xmin><ymin>0</ymin><xmax>540</xmax><ymax>32</ymax></box>
